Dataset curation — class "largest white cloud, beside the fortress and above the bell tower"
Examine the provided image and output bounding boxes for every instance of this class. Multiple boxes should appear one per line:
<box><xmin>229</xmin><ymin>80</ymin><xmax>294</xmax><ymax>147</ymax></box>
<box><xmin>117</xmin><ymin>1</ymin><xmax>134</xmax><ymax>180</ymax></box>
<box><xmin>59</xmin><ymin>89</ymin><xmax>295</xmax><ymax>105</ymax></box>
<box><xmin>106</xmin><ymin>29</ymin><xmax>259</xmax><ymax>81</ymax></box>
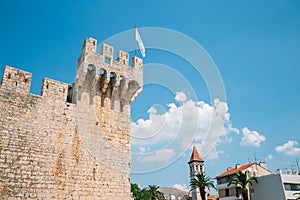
<box><xmin>131</xmin><ymin>92</ymin><xmax>238</xmax><ymax>168</ymax></box>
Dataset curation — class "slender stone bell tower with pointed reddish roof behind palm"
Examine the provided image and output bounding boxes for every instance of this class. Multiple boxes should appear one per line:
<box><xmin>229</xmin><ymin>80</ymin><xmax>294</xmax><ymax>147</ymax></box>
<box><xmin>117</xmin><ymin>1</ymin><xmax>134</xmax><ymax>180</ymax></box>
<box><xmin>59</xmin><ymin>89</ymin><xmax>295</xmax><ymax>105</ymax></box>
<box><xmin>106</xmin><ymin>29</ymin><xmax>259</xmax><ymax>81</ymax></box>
<box><xmin>188</xmin><ymin>146</ymin><xmax>204</xmax><ymax>200</ymax></box>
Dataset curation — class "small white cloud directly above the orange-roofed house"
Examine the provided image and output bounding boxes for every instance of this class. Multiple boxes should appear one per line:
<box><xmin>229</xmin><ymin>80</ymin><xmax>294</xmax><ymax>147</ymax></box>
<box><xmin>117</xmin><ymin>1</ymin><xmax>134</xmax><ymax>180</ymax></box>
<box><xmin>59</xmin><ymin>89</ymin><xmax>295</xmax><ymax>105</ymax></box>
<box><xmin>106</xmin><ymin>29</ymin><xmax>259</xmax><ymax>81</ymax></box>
<box><xmin>240</xmin><ymin>127</ymin><xmax>266</xmax><ymax>147</ymax></box>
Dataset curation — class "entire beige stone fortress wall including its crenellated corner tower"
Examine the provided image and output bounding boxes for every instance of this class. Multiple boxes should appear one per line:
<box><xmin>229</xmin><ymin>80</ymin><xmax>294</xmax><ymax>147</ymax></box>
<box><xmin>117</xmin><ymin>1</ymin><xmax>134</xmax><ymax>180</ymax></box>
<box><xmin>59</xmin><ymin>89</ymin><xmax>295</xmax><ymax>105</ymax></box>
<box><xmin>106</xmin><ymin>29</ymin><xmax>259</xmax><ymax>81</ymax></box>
<box><xmin>0</xmin><ymin>38</ymin><xmax>143</xmax><ymax>200</ymax></box>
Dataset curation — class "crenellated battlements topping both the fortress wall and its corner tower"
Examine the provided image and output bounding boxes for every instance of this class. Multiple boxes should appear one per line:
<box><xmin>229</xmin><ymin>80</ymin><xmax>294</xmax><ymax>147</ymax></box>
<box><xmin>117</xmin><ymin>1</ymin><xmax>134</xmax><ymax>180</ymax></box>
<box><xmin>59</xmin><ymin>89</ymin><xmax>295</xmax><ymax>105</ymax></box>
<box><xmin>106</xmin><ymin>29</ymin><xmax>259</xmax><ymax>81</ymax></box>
<box><xmin>0</xmin><ymin>38</ymin><xmax>143</xmax><ymax>108</ymax></box>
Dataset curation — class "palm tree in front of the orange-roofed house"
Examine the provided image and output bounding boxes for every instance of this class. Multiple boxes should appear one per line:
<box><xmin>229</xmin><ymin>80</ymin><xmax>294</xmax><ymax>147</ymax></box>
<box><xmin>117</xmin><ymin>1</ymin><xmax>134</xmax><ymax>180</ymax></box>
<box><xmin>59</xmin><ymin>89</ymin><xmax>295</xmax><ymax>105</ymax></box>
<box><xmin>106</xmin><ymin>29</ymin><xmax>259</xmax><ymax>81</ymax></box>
<box><xmin>227</xmin><ymin>171</ymin><xmax>258</xmax><ymax>200</ymax></box>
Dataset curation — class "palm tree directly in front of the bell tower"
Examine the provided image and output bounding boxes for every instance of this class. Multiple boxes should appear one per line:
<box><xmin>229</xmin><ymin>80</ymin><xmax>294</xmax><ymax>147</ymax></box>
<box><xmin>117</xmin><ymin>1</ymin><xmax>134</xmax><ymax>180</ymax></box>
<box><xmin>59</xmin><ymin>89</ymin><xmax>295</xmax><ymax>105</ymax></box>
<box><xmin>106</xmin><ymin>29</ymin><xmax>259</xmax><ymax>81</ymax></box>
<box><xmin>190</xmin><ymin>173</ymin><xmax>216</xmax><ymax>200</ymax></box>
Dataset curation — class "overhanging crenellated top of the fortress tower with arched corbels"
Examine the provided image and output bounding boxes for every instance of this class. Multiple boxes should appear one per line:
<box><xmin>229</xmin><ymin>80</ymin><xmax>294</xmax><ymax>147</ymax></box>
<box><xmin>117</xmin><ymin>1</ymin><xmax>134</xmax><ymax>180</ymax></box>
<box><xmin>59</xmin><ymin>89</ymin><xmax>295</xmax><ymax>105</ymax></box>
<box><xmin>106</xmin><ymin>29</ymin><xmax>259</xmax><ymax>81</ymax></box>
<box><xmin>71</xmin><ymin>38</ymin><xmax>143</xmax><ymax>107</ymax></box>
